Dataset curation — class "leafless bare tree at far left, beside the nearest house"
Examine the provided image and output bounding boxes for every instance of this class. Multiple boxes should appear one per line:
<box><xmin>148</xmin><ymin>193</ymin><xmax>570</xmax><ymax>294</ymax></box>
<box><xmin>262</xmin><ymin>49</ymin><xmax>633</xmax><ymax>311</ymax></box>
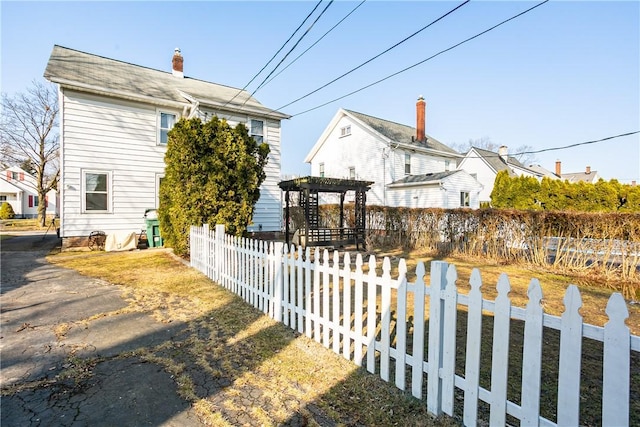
<box><xmin>0</xmin><ymin>81</ymin><xmax>60</xmax><ymax>226</ymax></box>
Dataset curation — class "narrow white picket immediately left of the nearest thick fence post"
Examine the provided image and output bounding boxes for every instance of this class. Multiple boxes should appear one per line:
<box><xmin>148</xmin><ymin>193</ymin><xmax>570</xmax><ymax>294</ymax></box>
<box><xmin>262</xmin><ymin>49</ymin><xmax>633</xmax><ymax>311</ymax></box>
<box><xmin>411</xmin><ymin>261</ymin><xmax>426</xmax><ymax>399</ymax></box>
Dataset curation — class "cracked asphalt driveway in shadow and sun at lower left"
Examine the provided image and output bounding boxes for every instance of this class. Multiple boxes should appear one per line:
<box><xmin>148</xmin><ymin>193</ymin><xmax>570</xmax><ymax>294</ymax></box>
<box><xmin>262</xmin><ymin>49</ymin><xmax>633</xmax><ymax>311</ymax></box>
<box><xmin>0</xmin><ymin>232</ymin><xmax>203</xmax><ymax>427</ymax></box>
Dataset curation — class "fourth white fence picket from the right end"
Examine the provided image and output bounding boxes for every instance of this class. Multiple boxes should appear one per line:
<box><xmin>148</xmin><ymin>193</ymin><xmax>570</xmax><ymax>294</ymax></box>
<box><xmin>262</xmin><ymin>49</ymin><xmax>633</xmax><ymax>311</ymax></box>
<box><xmin>489</xmin><ymin>273</ymin><xmax>511</xmax><ymax>426</ymax></box>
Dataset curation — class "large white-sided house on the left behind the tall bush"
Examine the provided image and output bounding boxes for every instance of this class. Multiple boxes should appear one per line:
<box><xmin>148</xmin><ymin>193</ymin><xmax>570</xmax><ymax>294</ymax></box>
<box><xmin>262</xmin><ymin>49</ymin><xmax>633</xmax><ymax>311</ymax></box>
<box><xmin>44</xmin><ymin>45</ymin><xmax>289</xmax><ymax>246</ymax></box>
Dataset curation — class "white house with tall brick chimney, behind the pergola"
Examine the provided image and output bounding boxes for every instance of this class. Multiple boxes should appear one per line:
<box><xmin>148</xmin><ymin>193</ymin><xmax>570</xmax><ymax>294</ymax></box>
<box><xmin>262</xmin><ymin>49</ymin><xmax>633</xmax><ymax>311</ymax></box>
<box><xmin>305</xmin><ymin>97</ymin><xmax>481</xmax><ymax>208</ymax></box>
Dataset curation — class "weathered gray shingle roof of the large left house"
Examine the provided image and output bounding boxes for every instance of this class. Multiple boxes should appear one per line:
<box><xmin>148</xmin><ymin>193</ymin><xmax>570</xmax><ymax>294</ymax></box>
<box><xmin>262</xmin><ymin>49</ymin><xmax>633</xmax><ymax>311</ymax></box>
<box><xmin>44</xmin><ymin>45</ymin><xmax>289</xmax><ymax>118</ymax></box>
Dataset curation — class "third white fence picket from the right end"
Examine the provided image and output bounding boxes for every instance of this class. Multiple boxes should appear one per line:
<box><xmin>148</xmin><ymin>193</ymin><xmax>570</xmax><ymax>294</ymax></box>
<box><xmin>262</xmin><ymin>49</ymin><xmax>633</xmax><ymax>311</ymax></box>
<box><xmin>520</xmin><ymin>279</ymin><xmax>544</xmax><ymax>426</ymax></box>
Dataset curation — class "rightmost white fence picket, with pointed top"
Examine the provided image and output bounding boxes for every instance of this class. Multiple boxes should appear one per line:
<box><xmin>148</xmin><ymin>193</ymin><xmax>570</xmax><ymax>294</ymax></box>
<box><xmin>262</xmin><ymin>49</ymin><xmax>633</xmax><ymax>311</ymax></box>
<box><xmin>602</xmin><ymin>292</ymin><xmax>631</xmax><ymax>426</ymax></box>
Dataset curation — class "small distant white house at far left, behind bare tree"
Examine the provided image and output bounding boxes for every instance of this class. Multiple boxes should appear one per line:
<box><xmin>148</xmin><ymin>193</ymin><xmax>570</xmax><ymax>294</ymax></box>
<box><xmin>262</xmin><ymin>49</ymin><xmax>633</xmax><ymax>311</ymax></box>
<box><xmin>0</xmin><ymin>166</ymin><xmax>58</xmax><ymax>218</ymax></box>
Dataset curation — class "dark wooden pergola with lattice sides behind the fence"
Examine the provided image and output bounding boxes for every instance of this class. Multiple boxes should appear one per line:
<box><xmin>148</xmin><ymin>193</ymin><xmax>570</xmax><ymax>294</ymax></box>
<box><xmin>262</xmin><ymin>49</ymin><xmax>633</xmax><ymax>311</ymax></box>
<box><xmin>278</xmin><ymin>176</ymin><xmax>373</xmax><ymax>249</ymax></box>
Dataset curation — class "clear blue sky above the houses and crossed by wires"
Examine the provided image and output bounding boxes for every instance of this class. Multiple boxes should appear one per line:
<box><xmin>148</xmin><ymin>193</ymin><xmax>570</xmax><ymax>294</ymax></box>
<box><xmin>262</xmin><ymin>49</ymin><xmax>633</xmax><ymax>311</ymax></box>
<box><xmin>0</xmin><ymin>0</ymin><xmax>640</xmax><ymax>183</ymax></box>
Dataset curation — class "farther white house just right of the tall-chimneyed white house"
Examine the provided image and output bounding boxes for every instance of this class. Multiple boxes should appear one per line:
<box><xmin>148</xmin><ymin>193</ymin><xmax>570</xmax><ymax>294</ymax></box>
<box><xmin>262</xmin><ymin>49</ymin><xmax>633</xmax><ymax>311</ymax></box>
<box><xmin>458</xmin><ymin>146</ymin><xmax>547</xmax><ymax>203</ymax></box>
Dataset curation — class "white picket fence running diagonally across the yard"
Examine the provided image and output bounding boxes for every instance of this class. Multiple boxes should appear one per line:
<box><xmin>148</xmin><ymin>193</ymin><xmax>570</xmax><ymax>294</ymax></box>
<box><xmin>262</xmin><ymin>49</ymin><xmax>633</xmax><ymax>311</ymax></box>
<box><xmin>190</xmin><ymin>225</ymin><xmax>640</xmax><ymax>426</ymax></box>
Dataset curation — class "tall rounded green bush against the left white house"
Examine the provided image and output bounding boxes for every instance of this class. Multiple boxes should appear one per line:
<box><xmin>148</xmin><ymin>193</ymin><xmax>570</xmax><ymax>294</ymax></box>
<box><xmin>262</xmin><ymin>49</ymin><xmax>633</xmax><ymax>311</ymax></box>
<box><xmin>158</xmin><ymin>117</ymin><xmax>269</xmax><ymax>255</ymax></box>
